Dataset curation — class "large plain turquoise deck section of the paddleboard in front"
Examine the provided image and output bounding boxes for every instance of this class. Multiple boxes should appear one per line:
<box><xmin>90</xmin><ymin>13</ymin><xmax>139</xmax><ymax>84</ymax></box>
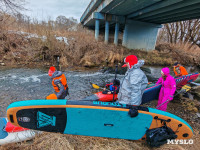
<box><xmin>64</xmin><ymin>108</ymin><xmax>153</xmax><ymax>140</ymax></box>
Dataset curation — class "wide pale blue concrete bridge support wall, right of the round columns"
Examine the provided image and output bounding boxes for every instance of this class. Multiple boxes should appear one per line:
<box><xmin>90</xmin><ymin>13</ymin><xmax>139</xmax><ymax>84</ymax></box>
<box><xmin>122</xmin><ymin>20</ymin><xmax>162</xmax><ymax>51</ymax></box>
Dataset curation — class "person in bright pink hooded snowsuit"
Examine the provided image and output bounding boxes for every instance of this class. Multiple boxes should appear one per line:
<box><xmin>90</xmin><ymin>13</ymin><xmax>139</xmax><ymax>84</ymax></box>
<box><xmin>156</xmin><ymin>67</ymin><xmax>176</xmax><ymax>111</ymax></box>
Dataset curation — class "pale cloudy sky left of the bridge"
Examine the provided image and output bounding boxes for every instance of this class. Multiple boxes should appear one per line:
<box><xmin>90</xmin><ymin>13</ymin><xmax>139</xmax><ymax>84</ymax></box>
<box><xmin>21</xmin><ymin>0</ymin><xmax>91</xmax><ymax>22</ymax></box>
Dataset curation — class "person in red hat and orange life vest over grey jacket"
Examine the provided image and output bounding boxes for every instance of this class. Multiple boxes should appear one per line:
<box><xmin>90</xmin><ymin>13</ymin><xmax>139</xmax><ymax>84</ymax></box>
<box><xmin>48</xmin><ymin>66</ymin><xmax>69</xmax><ymax>99</ymax></box>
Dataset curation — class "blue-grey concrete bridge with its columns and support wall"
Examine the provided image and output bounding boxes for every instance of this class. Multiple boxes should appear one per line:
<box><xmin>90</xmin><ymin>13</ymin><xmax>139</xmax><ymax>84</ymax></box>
<box><xmin>80</xmin><ymin>0</ymin><xmax>200</xmax><ymax>50</ymax></box>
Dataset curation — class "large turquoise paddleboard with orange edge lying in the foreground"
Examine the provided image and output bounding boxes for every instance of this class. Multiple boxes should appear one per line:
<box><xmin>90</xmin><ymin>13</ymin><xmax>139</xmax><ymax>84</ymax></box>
<box><xmin>7</xmin><ymin>100</ymin><xmax>193</xmax><ymax>140</ymax></box>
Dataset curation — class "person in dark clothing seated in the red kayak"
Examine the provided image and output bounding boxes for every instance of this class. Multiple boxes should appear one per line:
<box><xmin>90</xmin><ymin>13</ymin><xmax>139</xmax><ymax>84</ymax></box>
<box><xmin>102</xmin><ymin>79</ymin><xmax>120</xmax><ymax>94</ymax></box>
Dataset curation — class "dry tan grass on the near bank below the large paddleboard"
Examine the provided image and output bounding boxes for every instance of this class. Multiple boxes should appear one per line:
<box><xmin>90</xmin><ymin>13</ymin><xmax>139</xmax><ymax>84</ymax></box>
<box><xmin>0</xmin><ymin>130</ymin><xmax>200</xmax><ymax>150</ymax></box>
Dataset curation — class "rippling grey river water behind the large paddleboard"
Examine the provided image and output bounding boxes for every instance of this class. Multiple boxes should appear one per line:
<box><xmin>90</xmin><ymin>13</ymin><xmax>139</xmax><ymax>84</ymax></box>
<box><xmin>0</xmin><ymin>67</ymin><xmax>198</xmax><ymax>117</ymax></box>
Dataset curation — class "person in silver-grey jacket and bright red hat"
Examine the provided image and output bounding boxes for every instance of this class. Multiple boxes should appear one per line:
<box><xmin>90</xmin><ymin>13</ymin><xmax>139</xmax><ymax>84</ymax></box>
<box><xmin>118</xmin><ymin>55</ymin><xmax>148</xmax><ymax>106</ymax></box>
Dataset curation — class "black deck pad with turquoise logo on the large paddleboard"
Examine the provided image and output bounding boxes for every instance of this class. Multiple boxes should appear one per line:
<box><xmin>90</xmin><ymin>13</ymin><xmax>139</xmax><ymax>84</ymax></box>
<box><xmin>17</xmin><ymin>108</ymin><xmax>67</xmax><ymax>132</ymax></box>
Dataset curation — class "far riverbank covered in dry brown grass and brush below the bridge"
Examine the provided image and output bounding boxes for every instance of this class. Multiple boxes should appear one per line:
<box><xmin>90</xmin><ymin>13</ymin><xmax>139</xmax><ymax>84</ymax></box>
<box><xmin>0</xmin><ymin>27</ymin><xmax>200</xmax><ymax>68</ymax></box>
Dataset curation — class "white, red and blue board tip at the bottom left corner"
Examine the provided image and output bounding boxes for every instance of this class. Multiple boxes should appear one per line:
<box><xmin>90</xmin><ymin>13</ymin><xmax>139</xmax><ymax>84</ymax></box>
<box><xmin>0</xmin><ymin>118</ymin><xmax>37</xmax><ymax>145</ymax></box>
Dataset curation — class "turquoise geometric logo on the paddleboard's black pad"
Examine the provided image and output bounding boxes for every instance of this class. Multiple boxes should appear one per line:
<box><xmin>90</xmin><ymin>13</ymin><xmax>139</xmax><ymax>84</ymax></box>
<box><xmin>37</xmin><ymin>111</ymin><xmax>56</xmax><ymax>128</ymax></box>
